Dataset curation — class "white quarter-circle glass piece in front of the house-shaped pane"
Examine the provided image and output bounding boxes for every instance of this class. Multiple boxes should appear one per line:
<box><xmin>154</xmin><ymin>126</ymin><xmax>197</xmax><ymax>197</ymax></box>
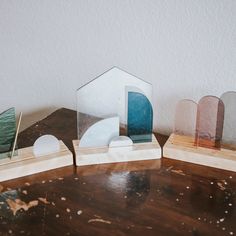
<box><xmin>79</xmin><ymin>116</ymin><xmax>120</xmax><ymax>147</ymax></box>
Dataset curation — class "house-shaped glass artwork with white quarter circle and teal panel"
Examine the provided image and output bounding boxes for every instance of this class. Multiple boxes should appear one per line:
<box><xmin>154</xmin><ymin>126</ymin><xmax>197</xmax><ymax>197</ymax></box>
<box><xmin>77</xmin><ymin>67</ymin><xmax>153</xmax><ymax>148</ymax></box>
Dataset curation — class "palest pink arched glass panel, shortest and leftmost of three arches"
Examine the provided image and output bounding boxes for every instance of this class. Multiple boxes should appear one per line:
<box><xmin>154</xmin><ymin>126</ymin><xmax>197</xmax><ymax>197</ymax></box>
<box><xmin>174</xmin><ymin>99</ymin><xmax>197</xmax><ymax>137</ymax></box>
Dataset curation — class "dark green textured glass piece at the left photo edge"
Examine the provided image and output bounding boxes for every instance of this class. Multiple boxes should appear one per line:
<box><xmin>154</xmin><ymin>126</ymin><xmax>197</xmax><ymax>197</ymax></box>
<box><xmin>0</xmin><ymin>108</ymin><xmax>16</xmax><ymax>159</ymax></box>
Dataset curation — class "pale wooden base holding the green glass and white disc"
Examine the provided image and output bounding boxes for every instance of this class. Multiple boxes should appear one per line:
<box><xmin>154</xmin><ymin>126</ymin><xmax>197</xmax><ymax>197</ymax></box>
<box><xmin>0</xmin><ymin>141</ymin><xmax>73</xmax><ymax>181</ymax></box>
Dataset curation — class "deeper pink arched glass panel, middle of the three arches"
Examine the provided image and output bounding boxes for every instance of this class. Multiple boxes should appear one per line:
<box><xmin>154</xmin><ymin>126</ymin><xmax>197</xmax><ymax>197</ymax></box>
<box><xmin>195</xmin><ymin>96</ymin><xmax>224</xmax><ymax>148</ymax></box>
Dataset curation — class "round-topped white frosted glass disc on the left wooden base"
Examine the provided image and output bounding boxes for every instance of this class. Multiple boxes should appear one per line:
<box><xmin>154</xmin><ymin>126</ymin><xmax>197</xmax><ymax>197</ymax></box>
<box><xmin>33</xmin><ymin>135</ymin><xmax>60</xmax><ymax>157</ymax></box>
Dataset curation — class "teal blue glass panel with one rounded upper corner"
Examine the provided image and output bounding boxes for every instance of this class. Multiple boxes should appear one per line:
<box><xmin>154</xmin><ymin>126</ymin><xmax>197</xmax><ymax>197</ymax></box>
<box><xmin>127</xmin><ymin>92</ymin><xmax>153</xmax><ymax>143</ymax></box>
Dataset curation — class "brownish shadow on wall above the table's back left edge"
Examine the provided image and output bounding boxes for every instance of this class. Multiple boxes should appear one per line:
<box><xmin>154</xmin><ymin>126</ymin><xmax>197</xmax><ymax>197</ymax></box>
<box><xmin>17</xmin><ymin>106</ymin><xmax>59</xmax><ymax>132</ymax></box>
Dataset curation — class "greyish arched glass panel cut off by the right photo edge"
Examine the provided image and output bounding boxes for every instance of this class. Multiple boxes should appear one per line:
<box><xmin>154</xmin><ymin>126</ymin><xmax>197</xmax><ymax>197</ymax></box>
<box><xmin>221</xmin><ymin>92</ymin><xmax>236</xmax><ymax>150</ymax></box>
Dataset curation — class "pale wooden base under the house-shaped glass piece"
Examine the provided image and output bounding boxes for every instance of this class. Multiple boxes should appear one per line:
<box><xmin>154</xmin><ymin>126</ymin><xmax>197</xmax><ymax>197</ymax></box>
<box><xmin>73</xmin><ymin>135</ymin><xmax>162</xmax><ymax>166</ymax></box>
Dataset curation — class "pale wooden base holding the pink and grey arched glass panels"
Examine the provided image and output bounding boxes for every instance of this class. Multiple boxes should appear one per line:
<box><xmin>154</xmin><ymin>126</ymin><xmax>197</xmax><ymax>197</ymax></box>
<box><xmin>163</xmin><ymin>134</ymin><xmax>236</xmax><ymax>171</ymax></box>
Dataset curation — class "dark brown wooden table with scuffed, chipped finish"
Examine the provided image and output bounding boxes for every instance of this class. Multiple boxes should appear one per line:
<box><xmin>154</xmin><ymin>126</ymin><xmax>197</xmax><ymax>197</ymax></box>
<box><xmin>0</xmin><ymin>109</ymin><xmax>236</xmax><ymax>236</ymax></box>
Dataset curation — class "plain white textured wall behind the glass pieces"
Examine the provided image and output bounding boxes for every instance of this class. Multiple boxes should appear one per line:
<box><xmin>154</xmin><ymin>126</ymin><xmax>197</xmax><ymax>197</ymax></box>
<box><xmin>0</xmin><ymin>0</ymin><xmax>236</xmax><ymax>133</ymax></box>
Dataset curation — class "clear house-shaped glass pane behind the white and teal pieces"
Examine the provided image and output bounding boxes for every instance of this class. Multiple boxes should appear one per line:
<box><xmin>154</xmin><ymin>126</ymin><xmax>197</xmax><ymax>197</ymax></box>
<box><xmin>77</xmin><ymin>67</ymin><xmax>152</xmax><ymax>148</ymax></box>
